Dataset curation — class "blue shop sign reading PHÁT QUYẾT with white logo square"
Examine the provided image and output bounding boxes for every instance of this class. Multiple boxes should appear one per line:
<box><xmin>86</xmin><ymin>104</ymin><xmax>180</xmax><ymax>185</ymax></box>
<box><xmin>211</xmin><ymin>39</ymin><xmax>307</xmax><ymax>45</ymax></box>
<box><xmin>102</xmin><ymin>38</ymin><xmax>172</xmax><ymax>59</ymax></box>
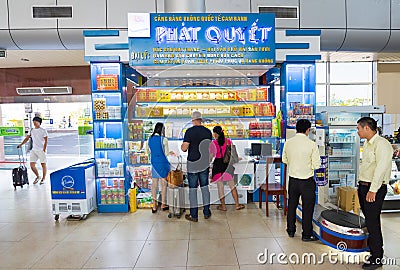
<box><xmin>128</xmin><ymin>13</ymin><xmax>275</xmax><ymax>66</ymax></box>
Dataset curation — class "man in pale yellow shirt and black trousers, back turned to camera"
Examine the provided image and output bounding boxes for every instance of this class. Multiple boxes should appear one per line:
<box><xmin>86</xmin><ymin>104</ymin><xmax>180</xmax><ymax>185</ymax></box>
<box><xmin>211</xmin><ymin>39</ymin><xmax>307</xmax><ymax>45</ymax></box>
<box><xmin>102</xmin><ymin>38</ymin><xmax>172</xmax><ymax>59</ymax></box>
<box><xmin>282</xmin><ymin>119</ymin><xmax>321</xmax><ymax>241</ymax></box>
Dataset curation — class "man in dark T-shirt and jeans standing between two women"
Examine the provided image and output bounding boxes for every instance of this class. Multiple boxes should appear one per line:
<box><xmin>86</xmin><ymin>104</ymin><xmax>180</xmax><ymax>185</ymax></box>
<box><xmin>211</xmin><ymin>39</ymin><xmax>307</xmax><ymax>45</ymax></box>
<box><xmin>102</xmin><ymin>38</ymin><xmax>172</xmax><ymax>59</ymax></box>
<box><xmin>181</xmin><ymin>111</ymin><xmax>212</xmax><ymax>222</ymax></box>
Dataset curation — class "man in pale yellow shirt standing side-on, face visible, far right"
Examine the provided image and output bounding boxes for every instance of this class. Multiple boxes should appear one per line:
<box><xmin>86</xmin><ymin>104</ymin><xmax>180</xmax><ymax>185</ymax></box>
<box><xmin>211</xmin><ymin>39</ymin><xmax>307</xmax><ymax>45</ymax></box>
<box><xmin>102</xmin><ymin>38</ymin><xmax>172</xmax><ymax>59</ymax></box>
<box><xmin>357</xmin><ymin>117</ymin><xmax>393</xmax><ymax>269</ymax></box>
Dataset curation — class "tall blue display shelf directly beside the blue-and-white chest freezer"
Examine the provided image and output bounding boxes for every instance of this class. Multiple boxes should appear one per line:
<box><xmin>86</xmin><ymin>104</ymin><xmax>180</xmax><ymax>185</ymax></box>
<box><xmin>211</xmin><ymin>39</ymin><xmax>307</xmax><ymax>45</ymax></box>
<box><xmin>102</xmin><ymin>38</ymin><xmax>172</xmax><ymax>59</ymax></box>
<box><xmin>90</xmin><ymin>63</ymin><xmax>130</xmax><ymax>212</ymax></box>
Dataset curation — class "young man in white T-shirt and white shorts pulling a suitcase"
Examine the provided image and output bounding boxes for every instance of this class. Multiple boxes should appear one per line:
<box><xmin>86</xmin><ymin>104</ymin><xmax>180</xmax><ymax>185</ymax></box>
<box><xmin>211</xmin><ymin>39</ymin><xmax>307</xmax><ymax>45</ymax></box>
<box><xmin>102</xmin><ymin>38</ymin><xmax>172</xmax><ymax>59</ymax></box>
<box><xmin>17</xmin><ymin>116</ymin><xmax>48</xmax><ymax>184</ymax></box>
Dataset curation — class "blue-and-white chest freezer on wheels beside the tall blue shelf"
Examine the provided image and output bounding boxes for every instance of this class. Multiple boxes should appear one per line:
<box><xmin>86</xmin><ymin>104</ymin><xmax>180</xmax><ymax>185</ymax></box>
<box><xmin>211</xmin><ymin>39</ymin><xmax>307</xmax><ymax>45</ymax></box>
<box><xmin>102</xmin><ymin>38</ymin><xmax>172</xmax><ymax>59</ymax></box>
<box><xmin>50</xmin><ymin>160</ymin><xmax>96</xmax><ymax>220</ymax></box>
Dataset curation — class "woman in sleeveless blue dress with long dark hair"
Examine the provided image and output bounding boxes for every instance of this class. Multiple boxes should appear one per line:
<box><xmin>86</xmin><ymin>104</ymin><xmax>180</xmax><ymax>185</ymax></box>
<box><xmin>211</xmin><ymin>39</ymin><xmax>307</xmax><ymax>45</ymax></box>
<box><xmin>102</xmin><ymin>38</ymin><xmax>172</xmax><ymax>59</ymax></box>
<box><xmin>146</xmin><ymin>123</ymin><xmax>171</xmax><ymax>213</ymax></box>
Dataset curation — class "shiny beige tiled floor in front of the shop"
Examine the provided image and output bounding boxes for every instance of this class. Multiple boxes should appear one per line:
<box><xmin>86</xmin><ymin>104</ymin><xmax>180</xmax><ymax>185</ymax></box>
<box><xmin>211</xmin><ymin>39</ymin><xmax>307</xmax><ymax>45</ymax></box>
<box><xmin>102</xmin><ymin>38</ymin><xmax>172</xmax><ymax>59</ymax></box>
<box><xmin>0</xmin><ymin>159</ymin><xmax>400</xmax><ymax>270</ymax></box>
